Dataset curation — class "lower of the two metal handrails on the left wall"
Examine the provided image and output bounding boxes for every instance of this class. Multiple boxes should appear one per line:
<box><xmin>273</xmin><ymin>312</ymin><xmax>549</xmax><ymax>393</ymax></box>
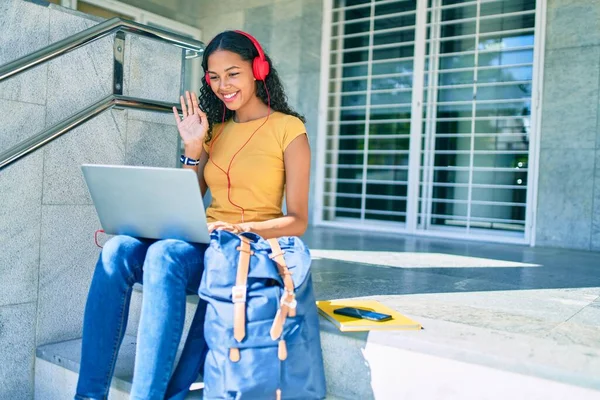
<box><xmin>0</xmin><ymin>94</ymin><xmax>179</xmax><ymax>170</ymax></box>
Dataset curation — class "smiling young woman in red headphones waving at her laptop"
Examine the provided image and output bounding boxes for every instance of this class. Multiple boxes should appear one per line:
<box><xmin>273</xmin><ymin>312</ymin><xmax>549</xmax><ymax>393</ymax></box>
<box><xmin>75</xmin><ymin>31</ymin><xmax>310</xmax><ymax>400</ymax></box>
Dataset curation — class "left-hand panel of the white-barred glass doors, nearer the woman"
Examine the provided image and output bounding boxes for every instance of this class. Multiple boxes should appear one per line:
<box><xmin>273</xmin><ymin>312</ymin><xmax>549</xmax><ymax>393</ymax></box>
<box><xmin>322</xmin><ymin>0</ymin><xmax>416</xmax><ymax>225</ymax></box>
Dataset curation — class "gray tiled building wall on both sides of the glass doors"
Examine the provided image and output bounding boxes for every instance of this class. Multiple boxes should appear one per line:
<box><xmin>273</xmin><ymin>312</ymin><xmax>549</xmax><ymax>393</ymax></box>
<box><xmin>86</xmin><ymin>0</ymin><xmax>600</xmax><ymax>251</ymax></box>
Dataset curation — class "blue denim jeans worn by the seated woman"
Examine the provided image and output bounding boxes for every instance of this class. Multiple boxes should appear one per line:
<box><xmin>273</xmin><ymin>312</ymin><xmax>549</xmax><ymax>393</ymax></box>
<box><xmin>75</xmin><ymin>236</ymin><xmax>207</xmax><ymax>400</ymax></box>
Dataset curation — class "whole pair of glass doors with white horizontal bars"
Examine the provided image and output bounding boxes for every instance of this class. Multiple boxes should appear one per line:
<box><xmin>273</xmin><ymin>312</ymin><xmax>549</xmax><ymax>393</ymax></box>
<box><xmin>317</xmin><ymin>0</ymin><xmax>540</xmax><ymax>242</ymax></box>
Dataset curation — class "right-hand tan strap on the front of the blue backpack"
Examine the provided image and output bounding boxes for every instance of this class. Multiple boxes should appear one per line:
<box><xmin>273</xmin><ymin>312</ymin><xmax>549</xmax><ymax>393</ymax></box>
<box><xmin>268</xmin><ymin>239</ymin><xmax>297</xmax><ymax>340</ymax></box>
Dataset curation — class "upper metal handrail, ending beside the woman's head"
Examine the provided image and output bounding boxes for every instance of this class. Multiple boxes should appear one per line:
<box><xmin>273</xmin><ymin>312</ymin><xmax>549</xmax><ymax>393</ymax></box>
<box><xmin>0</xmin><ymin>18</ymin><xmax>204</xmax><ymax>82</ymax></box>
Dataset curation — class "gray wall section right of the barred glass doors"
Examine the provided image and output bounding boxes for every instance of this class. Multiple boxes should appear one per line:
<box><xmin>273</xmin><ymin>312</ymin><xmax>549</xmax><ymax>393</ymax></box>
<box><xmin>536</xmin><ymin>0</ymin><xmax>600</xmax><ymax>251</ymax></box>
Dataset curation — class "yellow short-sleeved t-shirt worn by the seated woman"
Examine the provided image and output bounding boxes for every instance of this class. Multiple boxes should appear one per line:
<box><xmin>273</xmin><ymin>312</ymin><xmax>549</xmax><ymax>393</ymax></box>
<box><xmin>204</xmin><ymin>112</ymin><xmax>306</xmax><ymax>223</ymax></box>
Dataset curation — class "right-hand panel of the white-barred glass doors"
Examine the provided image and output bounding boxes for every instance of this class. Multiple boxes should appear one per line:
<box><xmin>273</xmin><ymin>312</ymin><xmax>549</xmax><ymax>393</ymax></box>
<box><xmin>419</xmin><ymin>0</ymin><xmax>535</xmax><ymax>236</ymax></box>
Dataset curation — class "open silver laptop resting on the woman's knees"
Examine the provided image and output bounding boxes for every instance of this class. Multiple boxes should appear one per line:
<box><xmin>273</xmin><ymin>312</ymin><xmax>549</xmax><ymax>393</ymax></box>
<box><xmin>81</xmin><ymin>164</ymin><xmax>210</xmax><ymax>243</ymax></box>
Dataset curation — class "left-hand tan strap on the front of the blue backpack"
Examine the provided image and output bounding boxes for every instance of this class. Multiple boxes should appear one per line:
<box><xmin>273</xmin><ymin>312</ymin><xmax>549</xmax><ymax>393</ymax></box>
<box><xmin>231</xmin><ymin>236</ymin><xmax>253</xmax><ymax>342</ymax></box>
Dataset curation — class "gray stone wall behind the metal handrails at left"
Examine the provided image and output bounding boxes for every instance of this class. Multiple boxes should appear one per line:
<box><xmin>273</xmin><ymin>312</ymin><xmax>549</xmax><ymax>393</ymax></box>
<box><xmin>0</xmin><ymin>0</ymin><xmax>181</xmax><ymax>400</ymax></box>
